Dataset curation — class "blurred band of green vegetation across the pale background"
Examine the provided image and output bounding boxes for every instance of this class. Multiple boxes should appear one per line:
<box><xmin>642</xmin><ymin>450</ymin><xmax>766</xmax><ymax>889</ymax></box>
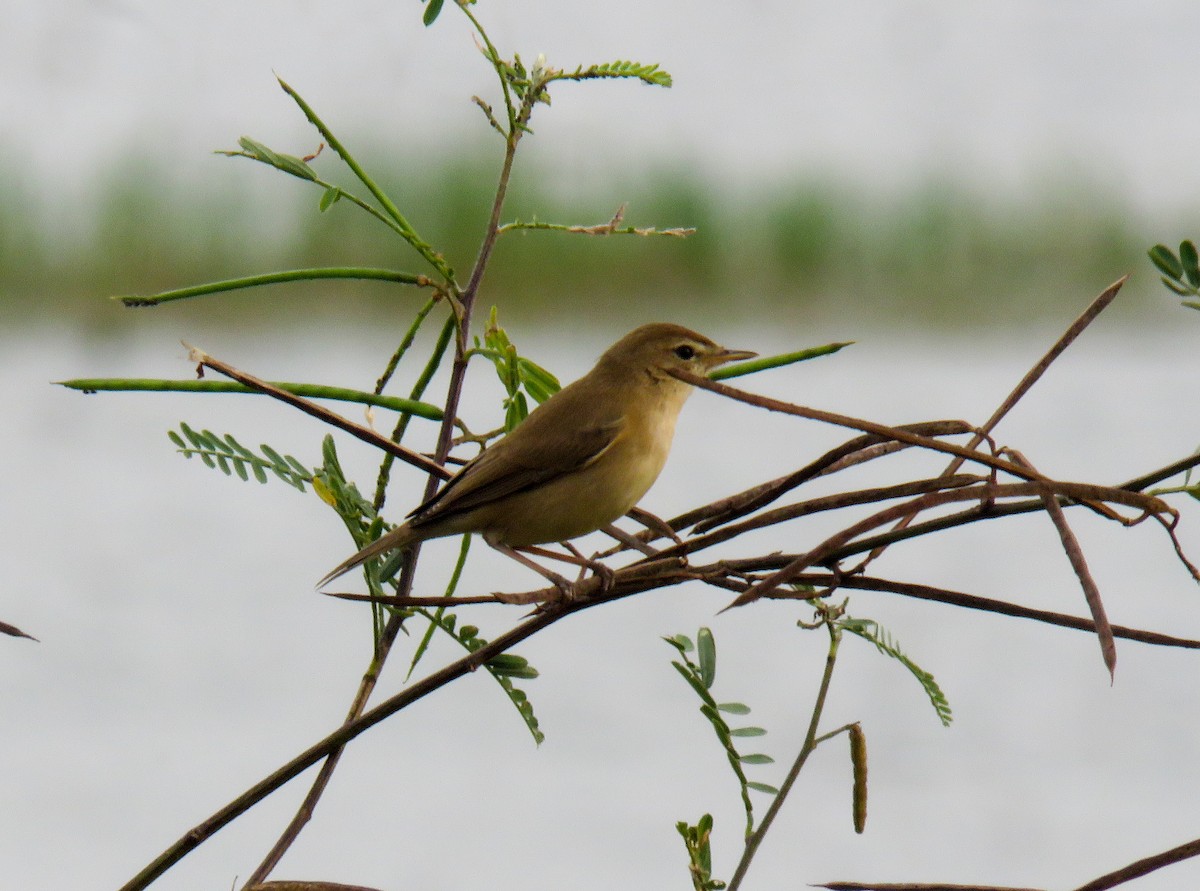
<box><xmin>0</xmin><ymin>153</ymin><xmax>1148</xmax><ymax>336</ymax></box>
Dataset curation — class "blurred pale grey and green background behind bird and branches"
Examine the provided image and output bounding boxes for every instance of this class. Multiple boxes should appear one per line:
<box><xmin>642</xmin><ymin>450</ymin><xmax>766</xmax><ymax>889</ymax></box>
<box><xmin>7</xmin><ymin>0</ymin><xmax>1200</xmax><ymax>890</ymax></box>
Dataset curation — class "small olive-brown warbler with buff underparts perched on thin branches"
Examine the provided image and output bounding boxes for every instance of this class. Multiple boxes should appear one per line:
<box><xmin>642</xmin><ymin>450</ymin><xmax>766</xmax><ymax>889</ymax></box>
<box><xmin>318</xmin><ymin>323</ymin><xmax>757</xmax><ymax>592</ymax></box>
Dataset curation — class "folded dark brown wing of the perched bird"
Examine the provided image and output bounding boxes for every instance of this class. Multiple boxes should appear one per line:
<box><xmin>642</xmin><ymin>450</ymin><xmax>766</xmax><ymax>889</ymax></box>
<box><xmin>409</xmin><ymin>414</ymin><xmax>625</xmax><ymax>527</ymax></box>
